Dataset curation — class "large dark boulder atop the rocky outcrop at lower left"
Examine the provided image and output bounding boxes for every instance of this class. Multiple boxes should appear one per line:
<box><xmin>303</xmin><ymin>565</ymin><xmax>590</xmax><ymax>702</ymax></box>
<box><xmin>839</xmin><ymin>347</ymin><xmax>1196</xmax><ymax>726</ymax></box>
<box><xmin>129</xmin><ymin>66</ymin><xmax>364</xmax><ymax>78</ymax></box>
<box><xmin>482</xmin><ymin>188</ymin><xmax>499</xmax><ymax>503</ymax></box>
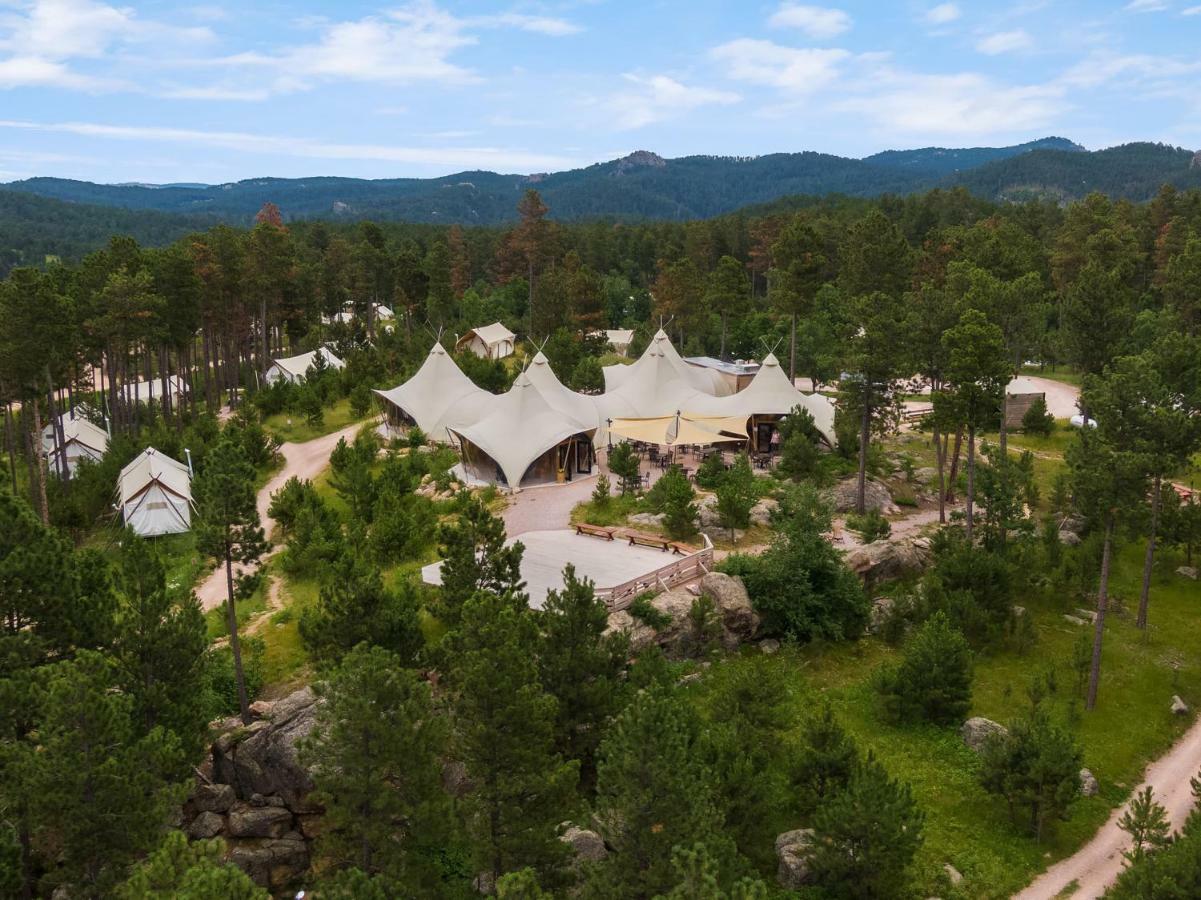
<box><xmin>213</xmin><ymin>687</ymin><xmax>322</xmax><ymax>812</ymax></box>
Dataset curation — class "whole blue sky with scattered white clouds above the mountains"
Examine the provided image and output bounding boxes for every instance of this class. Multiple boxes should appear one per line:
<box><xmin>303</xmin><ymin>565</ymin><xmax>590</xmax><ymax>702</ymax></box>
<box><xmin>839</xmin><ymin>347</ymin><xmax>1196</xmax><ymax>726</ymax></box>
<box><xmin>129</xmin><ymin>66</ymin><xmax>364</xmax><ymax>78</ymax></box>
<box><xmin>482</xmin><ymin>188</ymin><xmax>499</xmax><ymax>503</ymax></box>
<box><xmin>0</xmin><ymin>0</ymin><xmax>1201</xmax><ymax>184</ymax></box>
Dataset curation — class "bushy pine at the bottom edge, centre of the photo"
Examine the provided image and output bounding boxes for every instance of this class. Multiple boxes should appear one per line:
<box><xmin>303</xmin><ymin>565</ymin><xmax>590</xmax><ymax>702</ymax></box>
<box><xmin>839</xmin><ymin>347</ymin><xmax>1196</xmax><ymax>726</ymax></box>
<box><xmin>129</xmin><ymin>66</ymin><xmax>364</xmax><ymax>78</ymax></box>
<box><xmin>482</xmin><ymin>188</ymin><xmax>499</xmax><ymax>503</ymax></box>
<box><xmin>596</xmin><ymin>684</ymin><xmax>729</xmax><ymax>898</ymax></box>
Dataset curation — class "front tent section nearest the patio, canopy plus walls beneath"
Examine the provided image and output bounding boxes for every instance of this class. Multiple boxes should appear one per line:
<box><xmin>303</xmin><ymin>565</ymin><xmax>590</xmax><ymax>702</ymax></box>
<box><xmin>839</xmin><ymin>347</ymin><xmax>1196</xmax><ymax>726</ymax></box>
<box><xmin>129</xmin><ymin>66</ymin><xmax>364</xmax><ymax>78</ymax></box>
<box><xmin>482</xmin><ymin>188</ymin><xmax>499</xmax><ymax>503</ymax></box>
<box><xmin>450</xmin><ymin>372</ymin><xmax>597</xmax><ymax>490</ymax></box>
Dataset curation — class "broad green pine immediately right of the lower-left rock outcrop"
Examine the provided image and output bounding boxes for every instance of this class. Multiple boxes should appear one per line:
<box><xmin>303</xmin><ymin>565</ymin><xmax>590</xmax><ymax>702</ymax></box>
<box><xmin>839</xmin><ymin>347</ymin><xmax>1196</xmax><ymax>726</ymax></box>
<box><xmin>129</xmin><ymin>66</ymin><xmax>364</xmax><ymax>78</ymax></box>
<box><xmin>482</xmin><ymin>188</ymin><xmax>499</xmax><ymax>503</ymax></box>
<box><xmin>301</xmin><ymin>644</ymin><xmax>450</xmax><ymax>896</ymax></box>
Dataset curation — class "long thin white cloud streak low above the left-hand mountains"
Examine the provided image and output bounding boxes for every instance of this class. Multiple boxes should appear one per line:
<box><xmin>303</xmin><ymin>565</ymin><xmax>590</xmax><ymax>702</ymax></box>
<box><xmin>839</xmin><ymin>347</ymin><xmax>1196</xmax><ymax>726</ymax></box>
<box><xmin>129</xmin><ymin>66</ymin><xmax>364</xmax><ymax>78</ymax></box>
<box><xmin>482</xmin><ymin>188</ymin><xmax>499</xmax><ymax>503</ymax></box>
<box><xmin>0</xmin><ymin>120</ymin><xmax>581</xmax><ymax>172</ymax></box>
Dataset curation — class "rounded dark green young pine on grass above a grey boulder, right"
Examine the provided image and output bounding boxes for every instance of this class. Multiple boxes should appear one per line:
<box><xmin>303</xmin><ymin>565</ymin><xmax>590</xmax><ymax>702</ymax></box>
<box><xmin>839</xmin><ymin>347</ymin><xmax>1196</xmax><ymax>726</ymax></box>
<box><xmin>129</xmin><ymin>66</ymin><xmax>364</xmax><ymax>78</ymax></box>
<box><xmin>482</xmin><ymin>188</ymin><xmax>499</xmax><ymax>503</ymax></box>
<box><xmin>877</xmin><ymin>613</ymin><xmax>972</xmax><ymax>725</ymax></box>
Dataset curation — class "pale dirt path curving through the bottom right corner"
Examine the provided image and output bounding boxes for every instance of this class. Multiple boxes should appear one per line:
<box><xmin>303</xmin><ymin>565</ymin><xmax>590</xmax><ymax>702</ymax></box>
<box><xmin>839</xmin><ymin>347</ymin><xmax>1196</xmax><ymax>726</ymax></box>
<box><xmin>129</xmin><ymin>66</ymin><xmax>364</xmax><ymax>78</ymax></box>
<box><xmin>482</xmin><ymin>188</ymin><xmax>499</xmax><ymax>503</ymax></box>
<box><xmin>1016</xmin><ymin>720</ymin><xmax>1201</xmax><ymax>900</ymax></box>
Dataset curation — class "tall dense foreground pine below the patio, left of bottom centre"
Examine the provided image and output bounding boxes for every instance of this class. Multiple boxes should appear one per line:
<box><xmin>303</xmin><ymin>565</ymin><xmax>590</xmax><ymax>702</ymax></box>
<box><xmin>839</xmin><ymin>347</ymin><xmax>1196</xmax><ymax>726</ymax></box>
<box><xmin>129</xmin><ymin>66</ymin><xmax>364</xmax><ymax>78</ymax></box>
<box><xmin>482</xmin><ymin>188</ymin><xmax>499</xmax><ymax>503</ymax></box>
<box><xmin>449</xmin><ymin>591</ymin><xmax>579</xmax><ymax>881</ymax></box>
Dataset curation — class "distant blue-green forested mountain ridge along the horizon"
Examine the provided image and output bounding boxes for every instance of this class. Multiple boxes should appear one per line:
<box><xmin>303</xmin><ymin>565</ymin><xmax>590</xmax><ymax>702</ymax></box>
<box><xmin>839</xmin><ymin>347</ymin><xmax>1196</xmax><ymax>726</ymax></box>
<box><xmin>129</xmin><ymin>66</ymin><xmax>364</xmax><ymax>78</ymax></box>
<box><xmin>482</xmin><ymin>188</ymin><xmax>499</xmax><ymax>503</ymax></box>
<box><xmin>4</xmin><ymin>137</ymin><xmax>1201</xmax><ymax>225</ymax></box>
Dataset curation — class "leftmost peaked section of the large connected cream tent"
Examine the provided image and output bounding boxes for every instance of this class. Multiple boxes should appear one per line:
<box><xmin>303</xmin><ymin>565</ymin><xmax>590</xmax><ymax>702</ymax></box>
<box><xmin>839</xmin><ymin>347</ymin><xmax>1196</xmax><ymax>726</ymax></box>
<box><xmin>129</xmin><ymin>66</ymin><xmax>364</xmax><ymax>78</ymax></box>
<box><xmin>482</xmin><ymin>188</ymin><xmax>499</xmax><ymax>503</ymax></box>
<box><xmin>375</xmin><ymin>344</ymin><xmax>496</xmax><ymax>441</ymax></box>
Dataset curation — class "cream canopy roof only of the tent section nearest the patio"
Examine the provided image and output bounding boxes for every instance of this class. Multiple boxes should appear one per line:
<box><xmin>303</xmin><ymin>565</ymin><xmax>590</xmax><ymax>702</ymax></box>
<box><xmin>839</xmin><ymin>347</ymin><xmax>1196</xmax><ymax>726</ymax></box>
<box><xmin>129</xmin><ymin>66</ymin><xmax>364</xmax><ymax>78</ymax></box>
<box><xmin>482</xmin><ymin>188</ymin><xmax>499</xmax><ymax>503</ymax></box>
<box><xmin>450</xmin><ymin>372</ymin><xmax>597</xmax><ymax>488</ymax></box>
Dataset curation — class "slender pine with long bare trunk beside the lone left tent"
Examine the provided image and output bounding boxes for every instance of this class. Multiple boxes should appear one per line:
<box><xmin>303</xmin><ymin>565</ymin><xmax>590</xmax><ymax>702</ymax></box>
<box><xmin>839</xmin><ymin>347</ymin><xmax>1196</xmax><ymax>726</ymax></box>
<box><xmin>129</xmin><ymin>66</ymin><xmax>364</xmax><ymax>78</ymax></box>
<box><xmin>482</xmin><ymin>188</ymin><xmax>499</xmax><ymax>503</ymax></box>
<box><xmin>192</xmin><ymin>437</ymin><xmax>267</xmax><ymax>725</ymax></box>
